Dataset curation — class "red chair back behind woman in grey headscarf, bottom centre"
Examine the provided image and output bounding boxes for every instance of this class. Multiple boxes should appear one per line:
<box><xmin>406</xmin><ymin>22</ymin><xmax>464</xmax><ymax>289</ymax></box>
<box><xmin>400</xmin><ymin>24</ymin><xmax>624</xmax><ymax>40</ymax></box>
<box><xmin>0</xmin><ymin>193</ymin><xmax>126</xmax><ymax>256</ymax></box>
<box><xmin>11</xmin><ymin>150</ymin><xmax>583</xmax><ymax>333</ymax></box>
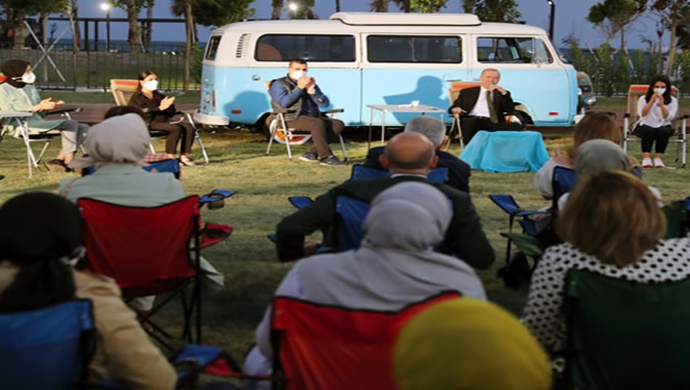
<box><xmin>272</xmin><ymin>292</ymin><xmax>460</xmax><ymax>390</ymax></box>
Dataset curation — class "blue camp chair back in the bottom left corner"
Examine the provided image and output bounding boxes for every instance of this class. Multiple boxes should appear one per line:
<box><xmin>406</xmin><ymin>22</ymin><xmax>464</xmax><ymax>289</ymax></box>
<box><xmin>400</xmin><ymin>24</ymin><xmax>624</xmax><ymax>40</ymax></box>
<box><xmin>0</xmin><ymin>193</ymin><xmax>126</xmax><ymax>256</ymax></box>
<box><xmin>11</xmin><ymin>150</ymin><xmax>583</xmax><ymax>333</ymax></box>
<box><xmin>0</xmin><ymin>300</ymin><xmax>96</xmax><ymax>389</ymax></box>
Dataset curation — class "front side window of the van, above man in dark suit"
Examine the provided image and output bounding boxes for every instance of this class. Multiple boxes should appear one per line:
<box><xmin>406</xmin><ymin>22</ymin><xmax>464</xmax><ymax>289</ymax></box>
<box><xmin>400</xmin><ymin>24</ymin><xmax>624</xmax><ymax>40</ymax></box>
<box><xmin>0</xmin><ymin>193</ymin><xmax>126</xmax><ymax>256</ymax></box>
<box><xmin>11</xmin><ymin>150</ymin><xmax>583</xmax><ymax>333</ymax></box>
<box><xmin>477</xmin><ymin>37</ymin><xmax>553</xmax><ymax>64</ymax></box>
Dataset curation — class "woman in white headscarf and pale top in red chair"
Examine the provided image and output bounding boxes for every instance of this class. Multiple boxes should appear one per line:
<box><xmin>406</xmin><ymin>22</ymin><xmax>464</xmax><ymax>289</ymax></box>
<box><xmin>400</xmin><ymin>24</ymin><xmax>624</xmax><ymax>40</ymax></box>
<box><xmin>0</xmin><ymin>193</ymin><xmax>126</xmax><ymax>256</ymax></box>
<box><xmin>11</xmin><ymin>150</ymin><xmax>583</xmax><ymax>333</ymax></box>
<box><xmin>60</xmin><ymin>114</ymin><xmax>224</xmax><ymax>312</ymax></box>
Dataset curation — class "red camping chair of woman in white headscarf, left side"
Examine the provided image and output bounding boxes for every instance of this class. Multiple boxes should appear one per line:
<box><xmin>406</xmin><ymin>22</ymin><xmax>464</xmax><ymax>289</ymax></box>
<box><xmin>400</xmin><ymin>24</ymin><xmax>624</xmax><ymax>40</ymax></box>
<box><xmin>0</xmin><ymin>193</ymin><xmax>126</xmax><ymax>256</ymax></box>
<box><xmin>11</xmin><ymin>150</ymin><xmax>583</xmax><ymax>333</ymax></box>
<box><xmin>77</xmin><ymin>195</ymin><xmax>201</xmax><ymax>349</ymax></box>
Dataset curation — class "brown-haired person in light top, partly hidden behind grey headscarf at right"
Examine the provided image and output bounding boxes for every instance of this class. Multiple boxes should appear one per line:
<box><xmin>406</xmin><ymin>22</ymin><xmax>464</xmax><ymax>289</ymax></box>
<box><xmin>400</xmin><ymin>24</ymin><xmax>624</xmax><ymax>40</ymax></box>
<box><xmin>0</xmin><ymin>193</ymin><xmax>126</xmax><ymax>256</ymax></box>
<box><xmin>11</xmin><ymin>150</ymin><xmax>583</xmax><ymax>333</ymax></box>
<box><xmin>534</xmin><ymin>112</ymin><xmax>622</xmax><ymax>199</ymax></box>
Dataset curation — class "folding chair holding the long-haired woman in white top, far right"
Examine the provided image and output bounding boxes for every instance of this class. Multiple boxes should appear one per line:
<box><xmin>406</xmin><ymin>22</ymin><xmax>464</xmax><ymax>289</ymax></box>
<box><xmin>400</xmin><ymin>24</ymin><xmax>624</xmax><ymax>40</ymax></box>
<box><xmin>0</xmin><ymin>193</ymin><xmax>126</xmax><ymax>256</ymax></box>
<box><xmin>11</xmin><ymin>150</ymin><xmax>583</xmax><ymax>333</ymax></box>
<box><xmin>623</xmin><ymin>84</ymin><xmax>689</xmax><ymax>168</ymax></box>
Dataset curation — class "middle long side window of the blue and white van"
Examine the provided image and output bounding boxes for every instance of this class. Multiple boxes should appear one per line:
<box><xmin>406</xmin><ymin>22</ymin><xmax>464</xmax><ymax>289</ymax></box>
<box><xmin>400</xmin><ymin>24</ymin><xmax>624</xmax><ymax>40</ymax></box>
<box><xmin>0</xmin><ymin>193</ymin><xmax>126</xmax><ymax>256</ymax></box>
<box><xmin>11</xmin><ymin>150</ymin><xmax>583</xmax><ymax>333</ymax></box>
<box><xmin>367</xmin><ymin>35</ymin><xmax>462</xmax><ymax>63</ymax></box>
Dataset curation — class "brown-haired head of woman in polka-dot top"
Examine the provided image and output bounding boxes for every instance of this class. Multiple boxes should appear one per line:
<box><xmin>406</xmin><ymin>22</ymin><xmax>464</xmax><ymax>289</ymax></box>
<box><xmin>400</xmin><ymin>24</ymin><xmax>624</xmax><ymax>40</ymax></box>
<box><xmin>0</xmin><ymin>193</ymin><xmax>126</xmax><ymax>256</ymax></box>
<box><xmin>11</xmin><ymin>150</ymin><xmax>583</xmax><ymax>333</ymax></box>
<box><xmin>556</xmin><ymin>170</ymin><xmax>666</xmax><ymax>266</ymax></box>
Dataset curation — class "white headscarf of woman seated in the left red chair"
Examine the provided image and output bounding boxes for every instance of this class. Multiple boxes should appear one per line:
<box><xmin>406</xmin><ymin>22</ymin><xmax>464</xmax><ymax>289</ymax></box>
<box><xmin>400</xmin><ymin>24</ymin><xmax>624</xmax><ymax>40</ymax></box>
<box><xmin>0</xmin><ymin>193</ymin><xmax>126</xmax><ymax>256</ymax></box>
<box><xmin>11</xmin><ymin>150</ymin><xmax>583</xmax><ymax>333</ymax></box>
<box><xmin>69</xmin><ymin>114</ymin><xmax>151</xmax><ymax>168</ymax></box>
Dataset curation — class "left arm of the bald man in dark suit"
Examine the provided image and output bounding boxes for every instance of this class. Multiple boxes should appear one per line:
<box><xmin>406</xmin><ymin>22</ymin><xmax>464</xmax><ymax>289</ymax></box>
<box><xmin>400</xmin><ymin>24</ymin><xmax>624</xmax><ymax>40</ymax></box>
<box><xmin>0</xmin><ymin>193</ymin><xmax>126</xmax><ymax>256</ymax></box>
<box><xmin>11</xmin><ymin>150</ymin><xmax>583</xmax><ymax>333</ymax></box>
<box><xmin>276</xmin><ymin>187</ymin><xmax>337</xmax><ymax>261</ymax></box>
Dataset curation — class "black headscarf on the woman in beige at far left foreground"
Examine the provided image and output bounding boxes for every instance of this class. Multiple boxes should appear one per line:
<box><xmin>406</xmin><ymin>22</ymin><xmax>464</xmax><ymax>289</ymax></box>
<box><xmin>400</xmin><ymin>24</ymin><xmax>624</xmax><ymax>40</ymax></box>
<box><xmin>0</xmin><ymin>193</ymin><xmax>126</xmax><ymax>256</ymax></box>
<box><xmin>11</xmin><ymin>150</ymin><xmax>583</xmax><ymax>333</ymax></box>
<box><xmin>0</xmin><ymin>192</ymin><xmax>84</xmax><ymax>312</ymax></box>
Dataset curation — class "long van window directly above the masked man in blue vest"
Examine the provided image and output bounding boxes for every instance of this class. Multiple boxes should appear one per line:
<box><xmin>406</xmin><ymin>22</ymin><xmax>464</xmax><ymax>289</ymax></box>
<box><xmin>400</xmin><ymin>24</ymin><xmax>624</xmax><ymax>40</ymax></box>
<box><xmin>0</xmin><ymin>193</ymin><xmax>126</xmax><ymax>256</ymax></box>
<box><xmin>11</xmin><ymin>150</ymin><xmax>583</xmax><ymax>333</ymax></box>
<box><xmin>254</xmin><ymin>34</ymin><xmax>355</xmax><ymax>62</ymax></box>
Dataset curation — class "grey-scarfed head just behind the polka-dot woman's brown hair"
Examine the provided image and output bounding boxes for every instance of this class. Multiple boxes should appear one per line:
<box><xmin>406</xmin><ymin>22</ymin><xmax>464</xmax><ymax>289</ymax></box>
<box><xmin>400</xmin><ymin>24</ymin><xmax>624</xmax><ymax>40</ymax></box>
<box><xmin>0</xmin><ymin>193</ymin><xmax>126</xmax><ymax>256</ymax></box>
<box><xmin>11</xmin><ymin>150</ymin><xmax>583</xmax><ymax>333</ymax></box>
<box><xmin>573</xmin><ymin>139</ymin><xmax>630</xmax><ymax>176</ymax></box>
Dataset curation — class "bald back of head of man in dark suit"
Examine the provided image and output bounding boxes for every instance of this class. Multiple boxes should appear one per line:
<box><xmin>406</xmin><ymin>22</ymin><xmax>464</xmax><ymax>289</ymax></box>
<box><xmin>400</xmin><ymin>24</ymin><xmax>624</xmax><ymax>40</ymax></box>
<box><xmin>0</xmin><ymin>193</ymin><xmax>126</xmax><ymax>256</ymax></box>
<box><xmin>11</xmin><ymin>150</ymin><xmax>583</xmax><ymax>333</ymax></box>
<box><xmin>380</xmin><ymin>132</ymin><xmax>438</xmax><ymax>176</ymax></box>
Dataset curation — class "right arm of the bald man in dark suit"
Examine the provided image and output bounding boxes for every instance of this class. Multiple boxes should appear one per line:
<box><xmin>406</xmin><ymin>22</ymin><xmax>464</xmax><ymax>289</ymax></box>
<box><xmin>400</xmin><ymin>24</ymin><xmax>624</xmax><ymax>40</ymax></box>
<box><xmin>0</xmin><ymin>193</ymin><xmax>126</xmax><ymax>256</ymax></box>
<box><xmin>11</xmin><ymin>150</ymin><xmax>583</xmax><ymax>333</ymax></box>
<box><xmin>445</xmin><ymin>191</ymin><xmax>496</xmax><ymax>269</ymax></box>
